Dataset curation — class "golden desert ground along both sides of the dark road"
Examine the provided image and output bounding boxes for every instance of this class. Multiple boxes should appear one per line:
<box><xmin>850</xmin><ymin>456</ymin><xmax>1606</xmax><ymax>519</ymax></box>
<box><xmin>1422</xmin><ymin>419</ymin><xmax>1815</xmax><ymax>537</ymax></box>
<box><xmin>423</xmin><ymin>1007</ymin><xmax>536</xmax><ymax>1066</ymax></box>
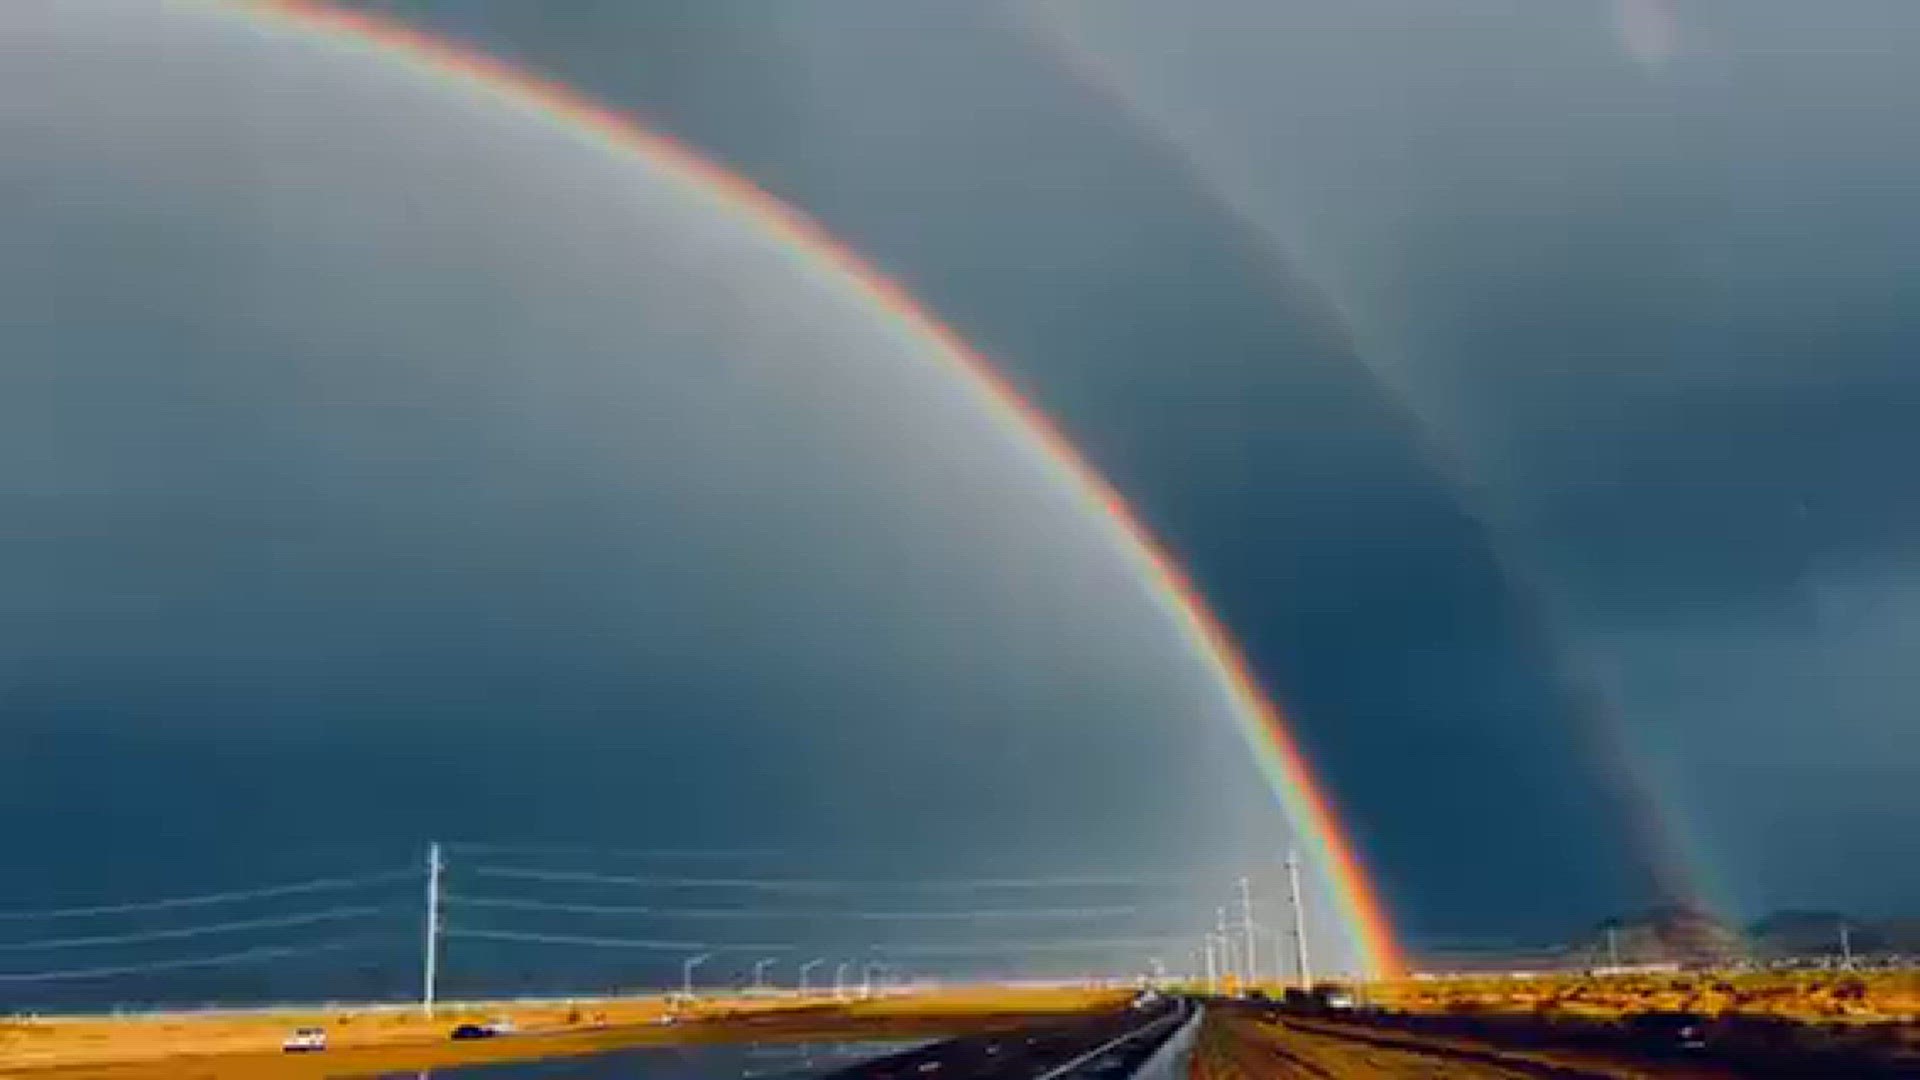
<box><xmin>0</xmin><ymin>970</ymin><xmax>1920</xmax><ymax>1080</ymax></box>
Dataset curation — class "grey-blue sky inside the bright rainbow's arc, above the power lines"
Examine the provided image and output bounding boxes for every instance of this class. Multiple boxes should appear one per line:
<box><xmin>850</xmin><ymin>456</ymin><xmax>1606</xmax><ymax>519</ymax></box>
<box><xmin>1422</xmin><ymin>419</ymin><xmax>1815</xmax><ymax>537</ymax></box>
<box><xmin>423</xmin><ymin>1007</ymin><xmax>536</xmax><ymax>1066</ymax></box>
<box><xmin>0</xmin><ymin>0</ymin><xmax>1279</xmax><ymax>994</ymax></box>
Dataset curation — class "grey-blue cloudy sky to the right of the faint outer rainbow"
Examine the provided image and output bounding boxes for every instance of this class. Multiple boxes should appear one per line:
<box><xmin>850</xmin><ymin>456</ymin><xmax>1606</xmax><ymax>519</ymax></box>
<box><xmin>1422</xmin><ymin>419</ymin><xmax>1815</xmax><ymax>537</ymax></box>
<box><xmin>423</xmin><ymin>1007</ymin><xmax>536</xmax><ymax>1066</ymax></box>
<box><xmin>1062</xmin><ymin>2</ymin><xmax>1920</xmax><ymax>907</ymax></box>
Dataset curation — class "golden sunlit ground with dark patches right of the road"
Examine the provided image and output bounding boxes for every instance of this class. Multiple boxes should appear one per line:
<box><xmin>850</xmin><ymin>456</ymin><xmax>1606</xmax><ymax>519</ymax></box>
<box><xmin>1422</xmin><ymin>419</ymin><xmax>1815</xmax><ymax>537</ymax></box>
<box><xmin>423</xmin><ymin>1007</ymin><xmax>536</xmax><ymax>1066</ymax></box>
<box><xmin>1196</xmin><ymin>970</ymin><xmax>1920</xmax><ymax>1080</ymax></box>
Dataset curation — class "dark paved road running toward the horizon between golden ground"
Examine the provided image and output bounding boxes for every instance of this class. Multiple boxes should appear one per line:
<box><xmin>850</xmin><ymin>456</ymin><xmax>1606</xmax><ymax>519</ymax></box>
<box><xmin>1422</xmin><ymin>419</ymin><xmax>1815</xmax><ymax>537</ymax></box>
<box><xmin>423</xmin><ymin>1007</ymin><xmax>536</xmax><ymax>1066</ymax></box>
<box><xmin>828</xmin><ymin>1001</ymin><xmax>1192</xmax><ymax>1080</ymax></box>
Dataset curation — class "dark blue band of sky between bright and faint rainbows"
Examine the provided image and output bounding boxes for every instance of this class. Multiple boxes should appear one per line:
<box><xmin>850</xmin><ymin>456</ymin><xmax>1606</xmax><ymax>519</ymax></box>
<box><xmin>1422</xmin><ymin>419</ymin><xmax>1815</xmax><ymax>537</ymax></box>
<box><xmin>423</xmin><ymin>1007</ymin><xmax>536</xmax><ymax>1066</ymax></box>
<box><xmin>341</xmin><ymin>2</ymin><xmax>1681</xmax><ymax>926</ymax></box>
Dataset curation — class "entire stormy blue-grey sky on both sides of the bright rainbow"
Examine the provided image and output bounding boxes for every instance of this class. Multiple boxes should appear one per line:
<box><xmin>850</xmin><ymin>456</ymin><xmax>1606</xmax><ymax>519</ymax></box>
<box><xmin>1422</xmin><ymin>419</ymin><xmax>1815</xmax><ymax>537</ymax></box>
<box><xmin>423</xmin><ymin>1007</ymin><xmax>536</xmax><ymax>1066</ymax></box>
<box><xmin>0</xmin><ymin>0</ymin><xmax>1920</xmax><ymax>999</ymax></box>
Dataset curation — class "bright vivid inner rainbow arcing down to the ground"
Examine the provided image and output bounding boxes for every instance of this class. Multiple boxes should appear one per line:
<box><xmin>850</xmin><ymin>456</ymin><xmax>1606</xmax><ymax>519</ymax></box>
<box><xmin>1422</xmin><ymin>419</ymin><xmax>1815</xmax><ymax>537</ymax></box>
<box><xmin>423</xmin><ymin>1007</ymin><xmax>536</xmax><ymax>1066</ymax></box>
<box><xmin>213</xmin><ymin>0</ymin><xmax>1404</xmax><ymax>978</ymax></box>
